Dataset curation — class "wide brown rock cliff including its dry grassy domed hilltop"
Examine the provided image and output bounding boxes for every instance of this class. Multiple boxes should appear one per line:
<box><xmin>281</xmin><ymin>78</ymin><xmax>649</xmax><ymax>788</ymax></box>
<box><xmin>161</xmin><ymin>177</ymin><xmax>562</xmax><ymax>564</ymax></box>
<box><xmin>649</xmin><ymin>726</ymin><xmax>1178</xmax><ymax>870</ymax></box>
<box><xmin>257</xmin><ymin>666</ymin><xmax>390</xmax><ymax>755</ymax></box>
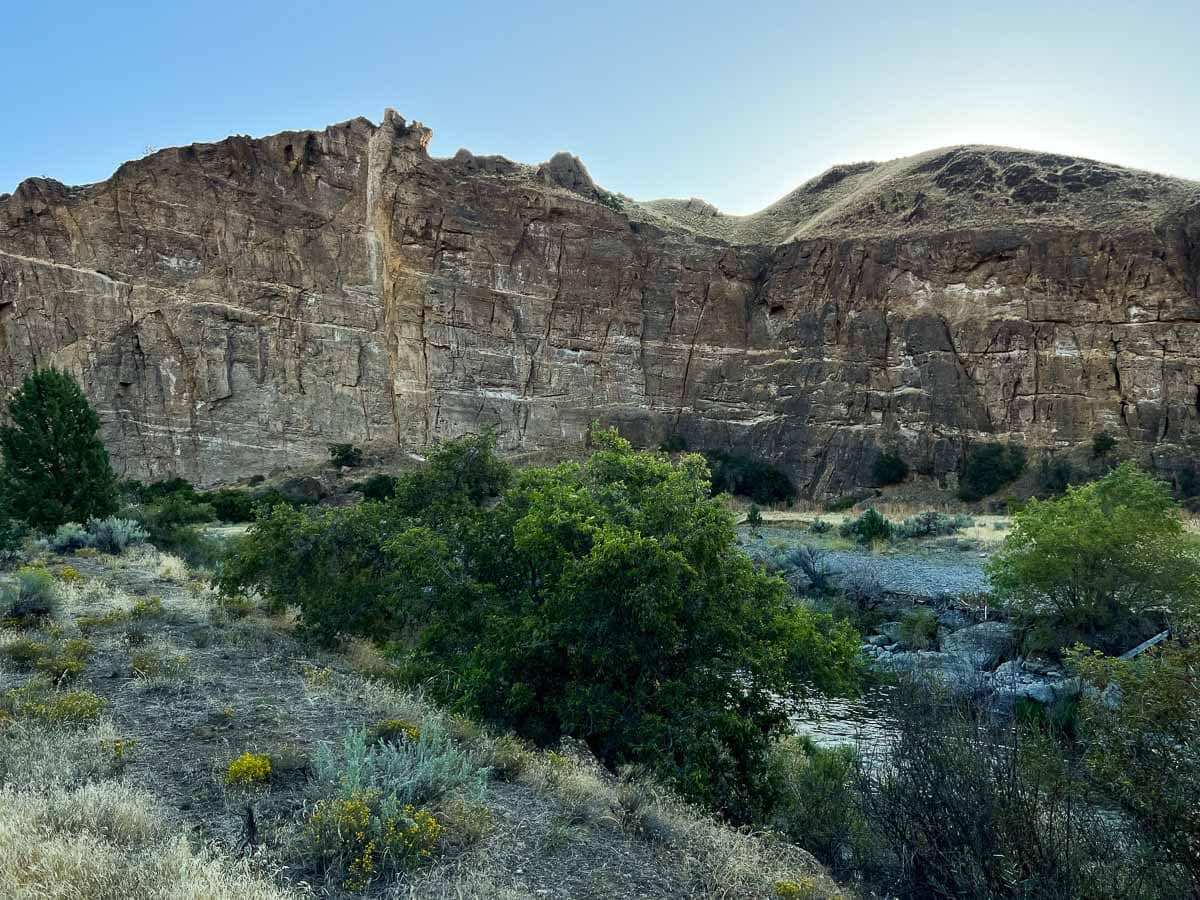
<box><xmin>0</xmin><ymin>112</ymin><xmax>1200</xmax><ymax>497</ymax></box>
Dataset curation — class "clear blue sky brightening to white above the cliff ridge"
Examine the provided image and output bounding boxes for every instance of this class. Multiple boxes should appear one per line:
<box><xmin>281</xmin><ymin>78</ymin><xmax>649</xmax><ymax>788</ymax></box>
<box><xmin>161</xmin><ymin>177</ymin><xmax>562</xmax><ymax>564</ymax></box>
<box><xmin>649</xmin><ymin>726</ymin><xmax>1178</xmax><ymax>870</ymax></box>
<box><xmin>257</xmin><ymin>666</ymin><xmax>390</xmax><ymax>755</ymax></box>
<box><xmin>0</xmin><ymin>0</ymin><xmax>1200</xmax><ymax>212</ymax></box>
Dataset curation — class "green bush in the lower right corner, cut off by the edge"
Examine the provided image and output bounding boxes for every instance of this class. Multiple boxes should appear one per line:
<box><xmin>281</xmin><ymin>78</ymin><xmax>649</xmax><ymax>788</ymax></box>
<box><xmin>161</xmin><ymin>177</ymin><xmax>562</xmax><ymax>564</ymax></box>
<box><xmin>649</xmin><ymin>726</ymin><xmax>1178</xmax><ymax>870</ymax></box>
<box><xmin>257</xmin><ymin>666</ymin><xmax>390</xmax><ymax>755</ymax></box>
<box><xmin>1070</xmin><ymin>630</ymin><xmax>1200</xmax><ymax>896</ymax></box>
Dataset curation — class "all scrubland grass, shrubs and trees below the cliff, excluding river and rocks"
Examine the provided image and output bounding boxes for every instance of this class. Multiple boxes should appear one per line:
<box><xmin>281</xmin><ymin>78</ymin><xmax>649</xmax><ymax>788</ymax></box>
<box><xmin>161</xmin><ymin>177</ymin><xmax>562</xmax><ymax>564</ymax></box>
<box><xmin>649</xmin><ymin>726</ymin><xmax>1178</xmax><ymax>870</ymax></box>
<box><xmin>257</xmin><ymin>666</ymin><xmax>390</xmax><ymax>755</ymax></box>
<box><xmin>0</xmin><ymin>373</ymin><xmax>1200</xmax><ymax>900</ymax></box>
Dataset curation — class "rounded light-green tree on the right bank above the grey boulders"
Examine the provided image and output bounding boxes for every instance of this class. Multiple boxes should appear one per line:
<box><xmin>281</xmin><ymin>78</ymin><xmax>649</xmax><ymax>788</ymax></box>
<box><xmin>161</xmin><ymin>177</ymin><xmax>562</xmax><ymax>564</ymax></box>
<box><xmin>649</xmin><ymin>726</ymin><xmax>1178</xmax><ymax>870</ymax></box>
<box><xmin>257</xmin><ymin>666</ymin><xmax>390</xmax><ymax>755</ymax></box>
<box><xmin>988</xmin><ymin>462</ymin><xmax>1200</xmax><ymax>649</ymax></box>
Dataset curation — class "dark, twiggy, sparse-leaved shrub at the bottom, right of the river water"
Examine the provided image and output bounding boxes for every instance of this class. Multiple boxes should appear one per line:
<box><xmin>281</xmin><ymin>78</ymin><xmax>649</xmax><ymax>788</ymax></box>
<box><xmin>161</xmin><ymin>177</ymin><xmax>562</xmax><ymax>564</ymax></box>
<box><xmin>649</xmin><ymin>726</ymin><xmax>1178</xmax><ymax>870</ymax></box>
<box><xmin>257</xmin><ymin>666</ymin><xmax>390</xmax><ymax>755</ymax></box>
<box><xmin>858</xmin><ymin>684</ymin><xmax>1156</xmax><ymax>900</ymax></box>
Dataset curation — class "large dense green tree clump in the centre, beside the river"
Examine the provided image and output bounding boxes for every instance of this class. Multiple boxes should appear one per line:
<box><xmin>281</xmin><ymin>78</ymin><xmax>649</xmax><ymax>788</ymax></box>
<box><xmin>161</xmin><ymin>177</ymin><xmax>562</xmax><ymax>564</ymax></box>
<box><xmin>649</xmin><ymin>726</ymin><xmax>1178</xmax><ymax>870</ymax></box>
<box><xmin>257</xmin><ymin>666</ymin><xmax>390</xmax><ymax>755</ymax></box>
<box><xmin>221</xmin><ymin>432</ymin><xmax>858</xmax><ymax>818</ymax></box>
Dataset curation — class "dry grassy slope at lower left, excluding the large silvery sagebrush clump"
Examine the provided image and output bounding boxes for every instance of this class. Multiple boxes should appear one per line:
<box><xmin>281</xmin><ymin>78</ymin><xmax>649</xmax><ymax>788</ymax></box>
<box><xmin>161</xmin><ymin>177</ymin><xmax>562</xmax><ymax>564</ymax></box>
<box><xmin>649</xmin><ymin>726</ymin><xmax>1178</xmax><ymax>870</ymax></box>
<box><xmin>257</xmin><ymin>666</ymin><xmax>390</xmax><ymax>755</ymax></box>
<box><xmin>0</xmin><ymin>550</ymin><xmax>842</xmax><ymax>900</ymax></box>
